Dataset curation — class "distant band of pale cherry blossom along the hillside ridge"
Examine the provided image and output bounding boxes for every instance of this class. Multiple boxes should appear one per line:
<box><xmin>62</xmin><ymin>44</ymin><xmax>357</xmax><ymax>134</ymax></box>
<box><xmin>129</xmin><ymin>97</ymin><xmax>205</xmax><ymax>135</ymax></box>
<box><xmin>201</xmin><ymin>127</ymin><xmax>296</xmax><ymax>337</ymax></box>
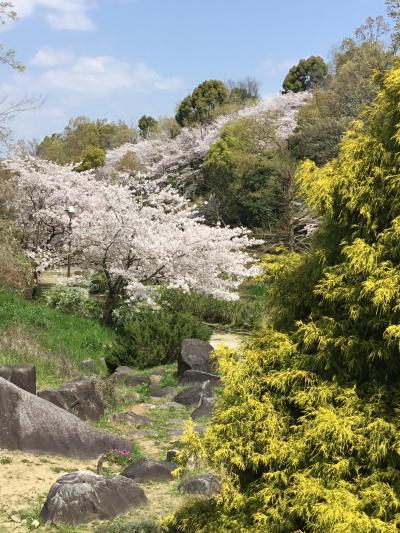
<box><xmin>106</xmin><ymin>92</ymin><xmax>309</xmax><ymax>187</ymax></box>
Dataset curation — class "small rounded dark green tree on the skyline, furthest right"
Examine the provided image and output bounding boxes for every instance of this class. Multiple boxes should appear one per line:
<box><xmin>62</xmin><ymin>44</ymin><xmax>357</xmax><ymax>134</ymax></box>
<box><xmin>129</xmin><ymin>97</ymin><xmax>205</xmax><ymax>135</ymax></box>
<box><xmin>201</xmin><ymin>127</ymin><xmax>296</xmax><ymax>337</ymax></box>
<box><xmin>282</xmin><ymin>56</ymin><xmax>328</xmax><ymax>93</ymax></box>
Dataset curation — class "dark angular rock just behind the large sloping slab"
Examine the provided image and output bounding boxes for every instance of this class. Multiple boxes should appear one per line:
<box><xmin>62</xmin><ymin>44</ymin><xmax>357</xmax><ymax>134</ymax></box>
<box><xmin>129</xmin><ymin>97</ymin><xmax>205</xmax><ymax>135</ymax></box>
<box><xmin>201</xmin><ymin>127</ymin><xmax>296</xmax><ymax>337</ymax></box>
<box><xmin>39</xmin><ymin>378</ymin><xmax>104</xmax><ymax>420</ymax></box>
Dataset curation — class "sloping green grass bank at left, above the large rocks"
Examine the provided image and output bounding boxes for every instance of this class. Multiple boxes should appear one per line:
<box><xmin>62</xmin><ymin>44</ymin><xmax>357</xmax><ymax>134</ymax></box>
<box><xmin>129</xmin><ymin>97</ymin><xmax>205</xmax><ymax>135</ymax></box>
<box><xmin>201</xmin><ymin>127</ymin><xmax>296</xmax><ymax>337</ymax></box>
<box><xmin>0</xmin><ymin>291</ymin><xmax>115</xmax><ymax>387</ymax></box>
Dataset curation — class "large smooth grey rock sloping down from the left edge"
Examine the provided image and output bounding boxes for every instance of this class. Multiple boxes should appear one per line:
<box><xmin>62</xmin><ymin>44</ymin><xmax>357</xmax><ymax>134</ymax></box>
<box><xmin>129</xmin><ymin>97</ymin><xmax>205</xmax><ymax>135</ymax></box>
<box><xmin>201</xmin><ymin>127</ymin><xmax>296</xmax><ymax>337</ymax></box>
<box><xmin>0</xmin><ymin>378</ymin><xmax>132</xmax><ymax>459</ymax></box>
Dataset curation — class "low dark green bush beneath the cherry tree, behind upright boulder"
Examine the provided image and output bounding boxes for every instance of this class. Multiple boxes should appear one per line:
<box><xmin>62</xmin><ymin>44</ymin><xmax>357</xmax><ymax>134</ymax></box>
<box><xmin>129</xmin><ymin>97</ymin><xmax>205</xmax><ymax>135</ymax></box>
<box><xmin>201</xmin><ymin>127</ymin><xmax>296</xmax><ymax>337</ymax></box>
<box><xmin>106</xmin><ymin>307</ymin><xmax>211</xmax><ymax>371</ymax></box>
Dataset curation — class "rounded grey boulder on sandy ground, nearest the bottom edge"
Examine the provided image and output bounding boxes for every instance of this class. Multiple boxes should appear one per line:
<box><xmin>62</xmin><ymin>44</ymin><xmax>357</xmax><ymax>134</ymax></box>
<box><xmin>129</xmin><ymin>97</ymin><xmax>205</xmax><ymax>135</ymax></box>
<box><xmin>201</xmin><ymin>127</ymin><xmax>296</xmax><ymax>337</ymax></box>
<box><xmin>40</xmin><ymin>471</ymin><xmax>148</xmax><ymax>526</ymax></box>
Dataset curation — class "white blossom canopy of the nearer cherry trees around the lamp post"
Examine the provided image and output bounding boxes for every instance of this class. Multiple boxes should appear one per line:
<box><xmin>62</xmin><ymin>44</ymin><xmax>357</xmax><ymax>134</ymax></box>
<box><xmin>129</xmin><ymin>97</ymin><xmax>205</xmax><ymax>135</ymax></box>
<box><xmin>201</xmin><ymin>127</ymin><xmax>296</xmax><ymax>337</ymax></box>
<box><xmin>6</xmin><ymin>157</ymin><xmax>258</xmax><ymax>299</ymax></box>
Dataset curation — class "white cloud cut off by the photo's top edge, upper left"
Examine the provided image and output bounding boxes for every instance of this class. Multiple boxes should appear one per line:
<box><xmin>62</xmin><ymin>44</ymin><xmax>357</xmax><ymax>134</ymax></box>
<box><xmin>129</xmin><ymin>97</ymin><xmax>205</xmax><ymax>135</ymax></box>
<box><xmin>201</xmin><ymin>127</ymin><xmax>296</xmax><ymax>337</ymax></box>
<box><xmin>13</xmin><ymin>0</ymin><xmax>96</xmax><ymax>31</ymax></box>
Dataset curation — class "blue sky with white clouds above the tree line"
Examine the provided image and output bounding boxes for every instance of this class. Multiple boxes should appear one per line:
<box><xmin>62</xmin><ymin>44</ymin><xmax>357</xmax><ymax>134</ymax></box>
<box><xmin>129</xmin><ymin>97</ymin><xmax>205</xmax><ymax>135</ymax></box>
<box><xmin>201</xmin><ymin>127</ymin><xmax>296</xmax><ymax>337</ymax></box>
<box><xmin>0</xmin><ymin>0</ymin><xmax>385</xmax><ymax>139</ymax></box>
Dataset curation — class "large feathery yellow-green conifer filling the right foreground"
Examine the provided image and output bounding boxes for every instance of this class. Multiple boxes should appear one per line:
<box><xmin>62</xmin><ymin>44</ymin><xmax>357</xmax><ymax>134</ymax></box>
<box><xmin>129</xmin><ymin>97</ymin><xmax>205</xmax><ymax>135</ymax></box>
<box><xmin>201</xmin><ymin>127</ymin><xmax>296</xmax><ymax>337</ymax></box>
<box><xmin>168</xmin><ymin>64</ymin><xmax>400</xmax><ymax>533</ymax></box>
